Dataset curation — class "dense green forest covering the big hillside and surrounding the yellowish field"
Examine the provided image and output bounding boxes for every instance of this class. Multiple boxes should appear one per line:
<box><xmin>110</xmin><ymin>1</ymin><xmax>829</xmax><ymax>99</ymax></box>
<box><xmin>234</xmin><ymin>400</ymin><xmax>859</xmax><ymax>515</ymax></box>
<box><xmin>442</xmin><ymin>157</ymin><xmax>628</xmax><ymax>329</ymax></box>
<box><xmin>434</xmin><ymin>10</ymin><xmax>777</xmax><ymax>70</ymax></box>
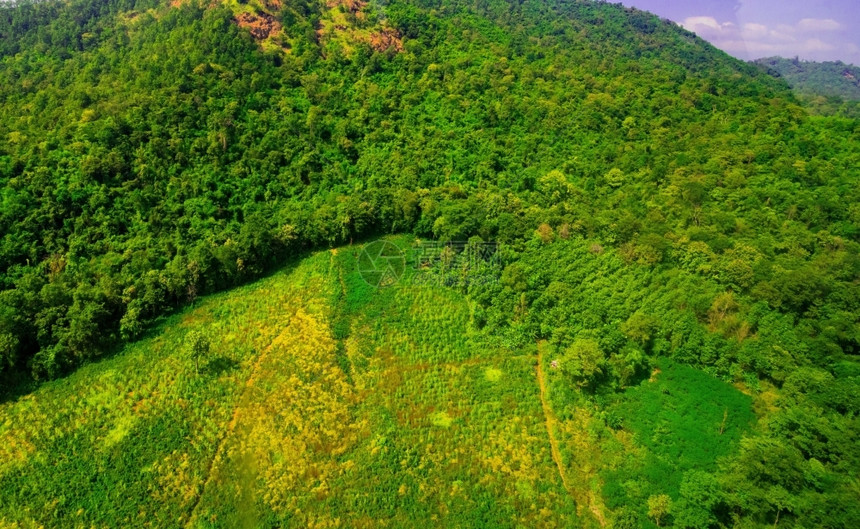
<box><xmin>0</xmin><ymin>0</ymin><xmax>860</xmax><ymax>528</ymax></box>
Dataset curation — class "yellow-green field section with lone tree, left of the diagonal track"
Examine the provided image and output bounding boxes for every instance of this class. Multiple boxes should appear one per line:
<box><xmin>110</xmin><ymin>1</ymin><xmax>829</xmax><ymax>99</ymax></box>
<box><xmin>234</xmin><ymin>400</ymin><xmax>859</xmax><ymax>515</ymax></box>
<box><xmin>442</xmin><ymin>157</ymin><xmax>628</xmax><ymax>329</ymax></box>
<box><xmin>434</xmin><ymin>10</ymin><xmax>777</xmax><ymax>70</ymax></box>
<box><xmin>0</xmin><ymin>254</ymin><xmax>324</xmax><ymax>527</ymax></box>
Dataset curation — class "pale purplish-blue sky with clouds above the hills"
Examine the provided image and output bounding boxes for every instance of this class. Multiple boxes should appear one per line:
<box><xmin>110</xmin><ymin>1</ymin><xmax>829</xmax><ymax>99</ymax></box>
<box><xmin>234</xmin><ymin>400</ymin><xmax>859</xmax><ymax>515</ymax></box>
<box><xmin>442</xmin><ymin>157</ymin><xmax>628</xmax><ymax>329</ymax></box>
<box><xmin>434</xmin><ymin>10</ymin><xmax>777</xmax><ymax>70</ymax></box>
<box><xmin>621</xmin><ymin>0</ymin><xmax>860</xmax><ymax>66</ymax></box>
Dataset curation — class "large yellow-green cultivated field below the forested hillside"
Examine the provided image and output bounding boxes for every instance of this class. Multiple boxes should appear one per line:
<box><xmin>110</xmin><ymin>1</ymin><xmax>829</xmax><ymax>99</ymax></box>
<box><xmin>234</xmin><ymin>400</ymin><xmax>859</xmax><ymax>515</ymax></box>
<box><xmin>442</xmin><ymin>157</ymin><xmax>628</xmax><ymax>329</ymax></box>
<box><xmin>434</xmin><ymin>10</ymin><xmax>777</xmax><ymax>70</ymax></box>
<box><xmin>0</xmin><ymin>239</ymin><xmax>750</xmax><ymax>528</ymax></box>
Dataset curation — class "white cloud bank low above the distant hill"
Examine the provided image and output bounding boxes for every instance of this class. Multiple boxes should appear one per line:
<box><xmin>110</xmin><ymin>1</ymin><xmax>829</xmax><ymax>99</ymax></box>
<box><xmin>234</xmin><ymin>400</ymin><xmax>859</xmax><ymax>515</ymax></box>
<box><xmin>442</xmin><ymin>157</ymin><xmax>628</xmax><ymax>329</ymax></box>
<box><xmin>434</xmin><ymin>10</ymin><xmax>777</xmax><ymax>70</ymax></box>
<box><xmin>681</xmin><ymin>16</ymin><xmax>860</xmax><ymax>60</ymax></box>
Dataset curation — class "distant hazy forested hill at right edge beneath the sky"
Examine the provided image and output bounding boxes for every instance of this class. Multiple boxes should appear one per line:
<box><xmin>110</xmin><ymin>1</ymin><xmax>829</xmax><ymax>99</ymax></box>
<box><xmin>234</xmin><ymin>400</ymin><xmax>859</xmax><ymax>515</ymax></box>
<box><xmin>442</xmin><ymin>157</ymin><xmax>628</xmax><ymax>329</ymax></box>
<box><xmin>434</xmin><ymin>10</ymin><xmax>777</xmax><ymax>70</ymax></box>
<box><xmin>754</xmin><ymin>57</ymin><xmax>860</xmax><ymax>118</ymax></box>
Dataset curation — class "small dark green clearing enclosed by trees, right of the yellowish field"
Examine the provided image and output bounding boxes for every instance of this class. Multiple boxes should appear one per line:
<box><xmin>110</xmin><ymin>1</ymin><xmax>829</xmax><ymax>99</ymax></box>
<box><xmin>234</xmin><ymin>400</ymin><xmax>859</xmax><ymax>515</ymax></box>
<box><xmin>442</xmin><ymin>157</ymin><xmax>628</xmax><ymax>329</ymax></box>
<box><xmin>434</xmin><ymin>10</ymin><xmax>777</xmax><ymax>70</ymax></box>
<box><xmin>604</xmin><ymin>359</ymin><xmax>755</xmax><ymax>524</ymax></box>
